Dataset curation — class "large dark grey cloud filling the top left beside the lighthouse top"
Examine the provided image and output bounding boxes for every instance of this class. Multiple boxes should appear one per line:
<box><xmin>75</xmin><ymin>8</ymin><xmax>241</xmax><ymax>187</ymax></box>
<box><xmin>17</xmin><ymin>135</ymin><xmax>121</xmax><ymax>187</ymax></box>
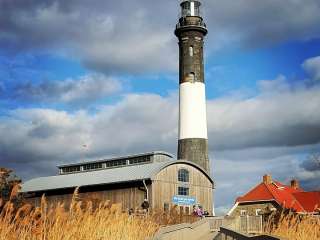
<box><xmin>0</xmin><ymin>0</ymin><xmax>177</xmax><ymax>73</ymax></box>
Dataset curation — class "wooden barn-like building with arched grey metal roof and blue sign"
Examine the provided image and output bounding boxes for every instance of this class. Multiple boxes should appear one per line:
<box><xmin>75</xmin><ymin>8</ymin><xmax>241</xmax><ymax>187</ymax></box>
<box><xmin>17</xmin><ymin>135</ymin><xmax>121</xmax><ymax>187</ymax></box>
<box><xmin>21</xmin><ymin>152</ymin><xmax>213</xmax><ymax>213</ymax></box>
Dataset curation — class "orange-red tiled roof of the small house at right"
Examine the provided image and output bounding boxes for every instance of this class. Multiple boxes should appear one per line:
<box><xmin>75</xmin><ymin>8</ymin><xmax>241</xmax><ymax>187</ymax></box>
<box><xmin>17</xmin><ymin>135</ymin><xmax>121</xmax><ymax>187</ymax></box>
<box><xmin>236</xmin><ymin>175</ymin><xmax>320</xmax><ymax>213</ymax></box>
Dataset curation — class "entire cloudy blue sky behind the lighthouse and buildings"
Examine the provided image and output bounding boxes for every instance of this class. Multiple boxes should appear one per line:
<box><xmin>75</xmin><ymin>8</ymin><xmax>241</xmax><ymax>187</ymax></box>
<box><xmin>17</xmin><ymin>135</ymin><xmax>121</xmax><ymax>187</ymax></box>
<box><xmin>0</xmin><ymin>0</ymin><xmax>320</xmax><ymax>214</ymax></box>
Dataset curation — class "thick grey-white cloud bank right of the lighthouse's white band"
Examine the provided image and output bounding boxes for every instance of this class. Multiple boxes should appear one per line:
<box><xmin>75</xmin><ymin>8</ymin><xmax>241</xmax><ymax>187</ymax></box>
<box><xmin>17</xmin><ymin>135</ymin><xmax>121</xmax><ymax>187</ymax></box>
<box><xmin>208</xmin><ymin>80</ymin><xmax>320</xmax><ymax>150</ymax></box>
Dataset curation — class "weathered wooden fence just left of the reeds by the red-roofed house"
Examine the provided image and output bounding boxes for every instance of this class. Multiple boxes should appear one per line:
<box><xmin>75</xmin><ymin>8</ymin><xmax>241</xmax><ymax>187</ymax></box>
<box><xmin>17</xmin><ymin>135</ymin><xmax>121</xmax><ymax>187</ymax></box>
<box><xmin>207</xmin><ymin>216</ymin><xmax>263</xmax><ymax>234</ymax></box>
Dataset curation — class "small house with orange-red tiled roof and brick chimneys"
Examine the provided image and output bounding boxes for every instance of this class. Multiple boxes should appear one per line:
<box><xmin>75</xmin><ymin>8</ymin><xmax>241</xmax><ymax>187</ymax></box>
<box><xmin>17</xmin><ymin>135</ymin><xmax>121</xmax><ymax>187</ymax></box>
<box><xmin>227</xmin><ymin>175</ymin><xmax>320</xmax><ymax>216</ymax></box>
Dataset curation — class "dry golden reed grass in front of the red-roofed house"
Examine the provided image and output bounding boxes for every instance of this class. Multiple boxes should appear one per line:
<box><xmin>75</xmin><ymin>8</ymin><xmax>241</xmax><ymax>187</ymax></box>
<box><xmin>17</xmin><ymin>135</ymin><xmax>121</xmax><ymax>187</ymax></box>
<box><xmin>266</xmin><ymin>213</ymin><xmax>320</xmax><ymax>240</ymax></box>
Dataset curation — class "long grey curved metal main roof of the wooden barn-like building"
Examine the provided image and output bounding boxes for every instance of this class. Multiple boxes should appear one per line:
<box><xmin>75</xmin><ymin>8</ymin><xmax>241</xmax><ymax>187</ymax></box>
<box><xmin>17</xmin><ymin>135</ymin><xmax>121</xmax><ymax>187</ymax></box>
<box><xmin>21</xmin><ymin>160</ymin><xmax>213</xmax><ymax>193</ymax></box>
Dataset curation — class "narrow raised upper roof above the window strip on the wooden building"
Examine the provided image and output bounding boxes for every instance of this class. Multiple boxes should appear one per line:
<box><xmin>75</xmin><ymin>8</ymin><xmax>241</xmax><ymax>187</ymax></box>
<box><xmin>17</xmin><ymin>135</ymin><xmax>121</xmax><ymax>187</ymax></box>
<box><xmin>57</xmin><ymin>151</ymin><xmax>174</xmax><ymax>168</ymax></box>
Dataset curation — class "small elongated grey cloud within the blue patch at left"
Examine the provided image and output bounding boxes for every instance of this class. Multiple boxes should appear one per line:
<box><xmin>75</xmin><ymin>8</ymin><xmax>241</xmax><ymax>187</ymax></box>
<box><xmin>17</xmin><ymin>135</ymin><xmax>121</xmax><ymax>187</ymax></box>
<box><xmin>0</xmin><ymin>74</ymin><xmax>122</xmax><ymax>104</ymax></box>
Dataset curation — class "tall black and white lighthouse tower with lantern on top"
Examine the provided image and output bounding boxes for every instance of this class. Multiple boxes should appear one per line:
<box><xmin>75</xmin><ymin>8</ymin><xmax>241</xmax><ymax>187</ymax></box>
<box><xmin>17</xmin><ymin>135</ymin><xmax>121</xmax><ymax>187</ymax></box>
<box><xmin>175</xmin><ymin>0</ymin><xmax>210</xmax><ymax>174</ymax></box>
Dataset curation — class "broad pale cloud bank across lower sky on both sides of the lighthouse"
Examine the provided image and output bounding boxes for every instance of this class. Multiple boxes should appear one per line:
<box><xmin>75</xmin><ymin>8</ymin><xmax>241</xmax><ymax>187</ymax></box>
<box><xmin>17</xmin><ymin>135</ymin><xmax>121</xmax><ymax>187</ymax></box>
<box><xmin>0</xmin><ymin>57</ymin><xmax>320</xmax><ymax>214</ymax></box>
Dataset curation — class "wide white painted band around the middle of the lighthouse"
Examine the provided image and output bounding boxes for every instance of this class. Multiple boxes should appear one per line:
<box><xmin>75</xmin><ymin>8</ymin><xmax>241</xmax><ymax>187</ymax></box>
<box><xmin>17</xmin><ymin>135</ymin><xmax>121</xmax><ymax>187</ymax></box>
<box><xmin>179</xmin><ymin>82</ymin><xmax>208</xmax><ymax>139</ymax></box>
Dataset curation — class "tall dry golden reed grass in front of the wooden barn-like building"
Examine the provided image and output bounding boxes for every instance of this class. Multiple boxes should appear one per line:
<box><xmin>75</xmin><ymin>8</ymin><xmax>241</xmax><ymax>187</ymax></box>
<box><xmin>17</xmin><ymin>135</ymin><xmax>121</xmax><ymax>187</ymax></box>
<box><xmin>0</xmin><ymin>193</ymin><xmax>160</xmax><ymax>240</ymax></box>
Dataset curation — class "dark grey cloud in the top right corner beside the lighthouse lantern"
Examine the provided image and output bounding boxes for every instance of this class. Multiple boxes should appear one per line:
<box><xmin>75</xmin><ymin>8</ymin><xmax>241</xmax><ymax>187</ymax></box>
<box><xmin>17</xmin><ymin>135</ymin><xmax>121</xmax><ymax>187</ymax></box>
<box><xmin>205</xmin><ymin>0</ymin><xmax>320</xmax><ymax>47</ymax></box>
